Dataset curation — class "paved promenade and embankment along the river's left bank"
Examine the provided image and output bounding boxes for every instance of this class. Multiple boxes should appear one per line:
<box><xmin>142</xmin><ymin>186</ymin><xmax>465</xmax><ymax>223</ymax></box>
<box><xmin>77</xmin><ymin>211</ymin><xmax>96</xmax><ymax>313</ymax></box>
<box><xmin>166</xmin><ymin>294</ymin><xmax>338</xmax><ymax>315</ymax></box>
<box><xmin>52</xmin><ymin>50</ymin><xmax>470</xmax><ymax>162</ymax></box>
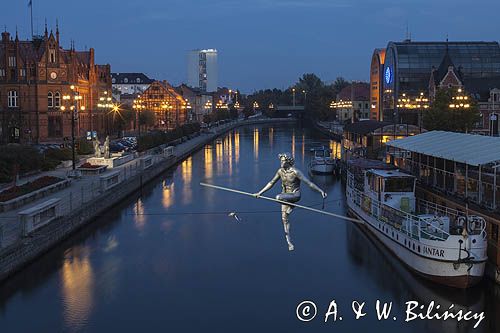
<box><xmin>0</xmin><ymin>118</ymin><xmax>295</xmax><ymax>281</ymax></box>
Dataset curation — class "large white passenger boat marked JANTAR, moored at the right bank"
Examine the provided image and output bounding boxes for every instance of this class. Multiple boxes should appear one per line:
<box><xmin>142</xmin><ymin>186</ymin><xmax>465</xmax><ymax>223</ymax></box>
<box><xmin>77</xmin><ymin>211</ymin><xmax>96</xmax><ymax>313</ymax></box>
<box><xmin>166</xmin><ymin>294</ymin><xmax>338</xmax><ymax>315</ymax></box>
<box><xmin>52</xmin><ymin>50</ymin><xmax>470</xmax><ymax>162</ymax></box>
<box><xmin>346</xmin><ymin>159</ymin><xmax>487</xmax><ymax>288</ymax></box>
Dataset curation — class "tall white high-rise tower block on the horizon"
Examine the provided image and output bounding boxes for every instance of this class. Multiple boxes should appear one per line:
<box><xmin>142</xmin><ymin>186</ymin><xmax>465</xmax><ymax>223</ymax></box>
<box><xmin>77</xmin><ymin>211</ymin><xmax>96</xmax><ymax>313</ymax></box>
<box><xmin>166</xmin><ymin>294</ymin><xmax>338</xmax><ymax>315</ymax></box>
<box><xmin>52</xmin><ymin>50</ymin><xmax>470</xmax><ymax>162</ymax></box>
<box><xmin>188</xmin><ymin>49</ymin><xmax>217</xmax><ymax>92</ymax></box>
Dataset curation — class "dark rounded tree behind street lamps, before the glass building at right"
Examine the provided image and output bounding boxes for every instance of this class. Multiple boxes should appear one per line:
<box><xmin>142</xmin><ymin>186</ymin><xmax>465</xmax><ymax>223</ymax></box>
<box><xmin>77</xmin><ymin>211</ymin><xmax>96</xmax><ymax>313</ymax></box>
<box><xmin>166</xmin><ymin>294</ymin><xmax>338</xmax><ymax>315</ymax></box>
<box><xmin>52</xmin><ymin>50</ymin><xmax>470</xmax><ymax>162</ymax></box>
<box><xmin>423</xmin><ymin>89</ymin><xmax>480</xmax><ymax>132</ymax></box>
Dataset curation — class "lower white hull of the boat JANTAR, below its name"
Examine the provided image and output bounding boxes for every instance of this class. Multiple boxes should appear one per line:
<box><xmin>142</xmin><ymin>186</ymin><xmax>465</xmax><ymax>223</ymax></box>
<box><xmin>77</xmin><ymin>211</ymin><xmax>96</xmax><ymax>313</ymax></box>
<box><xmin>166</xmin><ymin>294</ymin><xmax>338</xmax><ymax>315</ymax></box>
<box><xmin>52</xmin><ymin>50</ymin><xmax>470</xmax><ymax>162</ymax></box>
<box><xmin>348</xmin><ymin>200</ymin><xmax>486</xmax><ymax>289</ymax></box>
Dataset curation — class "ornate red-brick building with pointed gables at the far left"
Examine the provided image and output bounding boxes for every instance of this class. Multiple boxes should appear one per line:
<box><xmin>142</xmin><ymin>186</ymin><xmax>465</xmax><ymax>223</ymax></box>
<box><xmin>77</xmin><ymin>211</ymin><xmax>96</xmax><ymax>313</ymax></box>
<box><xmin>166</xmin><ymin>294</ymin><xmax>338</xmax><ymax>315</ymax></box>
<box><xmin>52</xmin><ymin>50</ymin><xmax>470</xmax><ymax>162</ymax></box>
<box><xmin>0</xmin><ymin>28</ymin><xmax>111</xmax><ymax>143</ymax></box>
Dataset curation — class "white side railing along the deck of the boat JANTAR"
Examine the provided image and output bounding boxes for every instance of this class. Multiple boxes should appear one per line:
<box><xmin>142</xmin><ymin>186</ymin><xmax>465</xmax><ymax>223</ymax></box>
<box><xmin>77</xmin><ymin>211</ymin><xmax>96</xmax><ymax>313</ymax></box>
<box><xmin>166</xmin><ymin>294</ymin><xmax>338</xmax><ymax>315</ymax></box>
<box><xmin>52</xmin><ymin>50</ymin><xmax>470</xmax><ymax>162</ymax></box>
<box><xmin>351</xmin><ymin>188</ymin><xmax>450</xmax><ymax>241</ymax></box>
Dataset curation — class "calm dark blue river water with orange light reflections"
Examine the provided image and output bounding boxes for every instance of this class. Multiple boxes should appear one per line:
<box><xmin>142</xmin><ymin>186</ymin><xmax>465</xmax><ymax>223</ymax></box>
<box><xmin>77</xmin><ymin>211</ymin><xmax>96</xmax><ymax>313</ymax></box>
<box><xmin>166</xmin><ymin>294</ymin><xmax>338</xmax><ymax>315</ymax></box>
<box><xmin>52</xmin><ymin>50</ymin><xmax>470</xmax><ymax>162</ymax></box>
<box><xmin>0</xmin><ymin>125</ymin><xmax>500</xmax><ymax>333</ymax></box>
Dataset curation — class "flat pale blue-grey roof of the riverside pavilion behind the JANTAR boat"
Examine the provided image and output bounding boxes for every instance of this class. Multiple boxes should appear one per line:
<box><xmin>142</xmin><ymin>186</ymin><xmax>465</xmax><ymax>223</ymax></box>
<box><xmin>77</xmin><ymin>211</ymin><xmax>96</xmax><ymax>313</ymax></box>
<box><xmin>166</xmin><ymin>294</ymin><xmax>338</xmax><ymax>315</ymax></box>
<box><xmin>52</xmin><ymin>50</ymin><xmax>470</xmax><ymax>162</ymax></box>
<box><xmin>386</xmin><ymin>131</ymin><xmax>500</xmax><ymax>166</ymax></box>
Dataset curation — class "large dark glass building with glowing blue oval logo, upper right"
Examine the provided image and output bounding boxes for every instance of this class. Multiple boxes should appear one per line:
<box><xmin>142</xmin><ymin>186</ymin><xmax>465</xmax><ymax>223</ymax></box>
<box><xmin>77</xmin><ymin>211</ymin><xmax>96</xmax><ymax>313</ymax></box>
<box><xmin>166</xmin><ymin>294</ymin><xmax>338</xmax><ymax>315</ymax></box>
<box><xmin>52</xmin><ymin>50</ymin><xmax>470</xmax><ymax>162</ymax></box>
<box><xmin>381</xmin><ymin>40</ymin><xmax>500</xmax><ymax>122</ymax></box>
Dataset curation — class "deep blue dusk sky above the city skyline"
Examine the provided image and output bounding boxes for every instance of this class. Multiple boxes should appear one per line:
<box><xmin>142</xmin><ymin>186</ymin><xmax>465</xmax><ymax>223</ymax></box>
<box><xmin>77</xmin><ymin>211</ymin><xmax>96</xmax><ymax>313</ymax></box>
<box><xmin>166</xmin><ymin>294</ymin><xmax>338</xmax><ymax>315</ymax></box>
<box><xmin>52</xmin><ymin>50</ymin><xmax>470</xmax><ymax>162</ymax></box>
<box><xmin>1</xmin><ymin>0</ymin><xmax>500</xmax><ymax>93</ymax></box>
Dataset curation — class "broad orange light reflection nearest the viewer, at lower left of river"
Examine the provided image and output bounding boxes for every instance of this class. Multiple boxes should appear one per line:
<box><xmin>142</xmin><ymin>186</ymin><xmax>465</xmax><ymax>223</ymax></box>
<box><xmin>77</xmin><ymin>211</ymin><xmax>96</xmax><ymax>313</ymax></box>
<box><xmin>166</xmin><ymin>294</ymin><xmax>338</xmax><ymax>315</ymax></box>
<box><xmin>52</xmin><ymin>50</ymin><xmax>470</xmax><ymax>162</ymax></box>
<box><xmin>61</xmin><ymin>247</ymin><xmax>94</xmax><ymax>330</ymax></box>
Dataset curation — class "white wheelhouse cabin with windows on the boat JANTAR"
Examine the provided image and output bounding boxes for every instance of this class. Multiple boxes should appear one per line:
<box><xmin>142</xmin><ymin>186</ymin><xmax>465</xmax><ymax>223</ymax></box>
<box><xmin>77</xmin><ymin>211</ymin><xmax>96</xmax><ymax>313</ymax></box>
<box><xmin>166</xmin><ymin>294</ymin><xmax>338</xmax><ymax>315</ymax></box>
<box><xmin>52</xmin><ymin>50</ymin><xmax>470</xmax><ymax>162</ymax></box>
<box><xmin>364</xmin><ymin>169</ymin><xmax>416</xmax><ymax>213</ymax></box>
